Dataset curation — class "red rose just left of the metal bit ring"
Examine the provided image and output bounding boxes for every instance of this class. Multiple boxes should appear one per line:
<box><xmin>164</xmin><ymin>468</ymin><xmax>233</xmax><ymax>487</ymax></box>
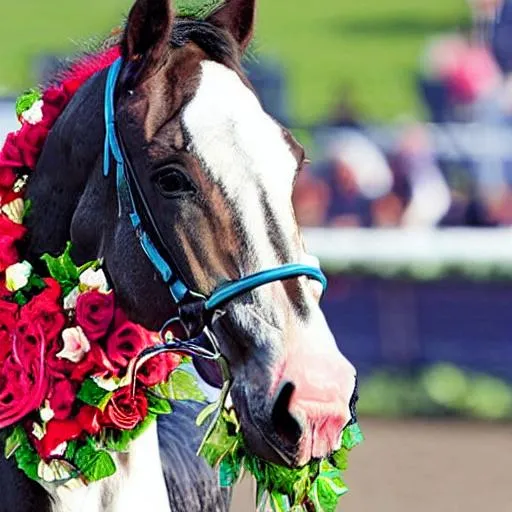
<box><xmin>107</xmin><ymin>322</ymin><xmax>153</xmax><ymax>370</ymax></box>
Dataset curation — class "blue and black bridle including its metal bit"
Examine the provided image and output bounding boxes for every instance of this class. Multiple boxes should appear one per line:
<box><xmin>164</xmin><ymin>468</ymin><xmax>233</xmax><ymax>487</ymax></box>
<box><xmin>103</xmin><ymin>58</ymin><xmax>327</xmax><ymax>378</ymax></box>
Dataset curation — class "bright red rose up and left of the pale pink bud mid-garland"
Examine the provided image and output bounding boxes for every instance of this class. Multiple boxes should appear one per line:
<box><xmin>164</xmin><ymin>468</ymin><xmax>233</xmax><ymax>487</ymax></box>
<box><xmin>20</xmin><ymin>278</ymin><xmax>66</xmax><ymax>342</ymax></box>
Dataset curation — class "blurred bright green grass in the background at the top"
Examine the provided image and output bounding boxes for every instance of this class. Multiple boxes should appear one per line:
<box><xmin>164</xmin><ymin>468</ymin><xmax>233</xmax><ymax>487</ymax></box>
<box><xmin>0</xmin><ymin>0</ymin><xmax>468</xmax><ymax>122</ymax></box>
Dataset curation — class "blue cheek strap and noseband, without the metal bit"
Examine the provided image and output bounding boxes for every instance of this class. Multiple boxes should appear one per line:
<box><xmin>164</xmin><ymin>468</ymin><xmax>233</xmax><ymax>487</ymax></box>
<box><xmin>103</xmin><ymin>58</ymin><xmax>327</xmax><ymax>320</ymax></box>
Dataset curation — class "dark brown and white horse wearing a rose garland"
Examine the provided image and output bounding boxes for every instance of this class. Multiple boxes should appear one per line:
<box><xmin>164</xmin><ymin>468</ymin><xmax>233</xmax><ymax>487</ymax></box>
<box><xmin>0</xmin><ymin>0</ymin><xmax>356</xmax><ymax>512</ymax></box>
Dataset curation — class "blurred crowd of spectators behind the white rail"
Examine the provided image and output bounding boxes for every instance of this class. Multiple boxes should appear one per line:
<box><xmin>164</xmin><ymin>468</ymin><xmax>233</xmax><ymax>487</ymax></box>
<box><xmin>286</xmin><ymin>0</ymin><xmax>512</xmax><ymax>227</ymax></box>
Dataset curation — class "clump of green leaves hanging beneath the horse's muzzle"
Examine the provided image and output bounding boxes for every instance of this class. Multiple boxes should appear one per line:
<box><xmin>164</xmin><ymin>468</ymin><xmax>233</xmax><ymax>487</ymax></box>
<box><xmin>200</xmin><ymin>404</ymin><xmax>363</xmax><ymax>512</ymax></box>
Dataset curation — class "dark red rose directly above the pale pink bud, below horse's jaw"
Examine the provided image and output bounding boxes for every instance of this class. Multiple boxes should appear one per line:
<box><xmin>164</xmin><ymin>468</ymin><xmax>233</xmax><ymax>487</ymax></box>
<box><xmin>76</xmin><ymin>290</ymin><xmax>114</xmax><ymax>341</ymax></box>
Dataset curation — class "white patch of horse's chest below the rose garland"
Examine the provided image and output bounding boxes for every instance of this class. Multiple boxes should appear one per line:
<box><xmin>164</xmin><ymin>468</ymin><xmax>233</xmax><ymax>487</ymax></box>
<box><xmin>47</xmin><ymin>422</ymin><xmax>170</xmax><ymax>512</ymax></box>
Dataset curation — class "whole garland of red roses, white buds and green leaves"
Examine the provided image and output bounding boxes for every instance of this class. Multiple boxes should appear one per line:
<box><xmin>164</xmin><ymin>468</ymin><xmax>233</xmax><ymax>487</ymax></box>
<box><xmin>0</xmin><ymin>39</ymin><xmax>363</xmax><ymax>512</ymax></box>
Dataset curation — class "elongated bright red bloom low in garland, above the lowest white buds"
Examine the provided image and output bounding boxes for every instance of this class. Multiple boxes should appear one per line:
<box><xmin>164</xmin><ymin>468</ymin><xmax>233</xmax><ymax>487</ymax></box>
<box><xmin>34</xmin><ymin>405</ymin><xmax>101</xmax><ymax>460</ymax></box>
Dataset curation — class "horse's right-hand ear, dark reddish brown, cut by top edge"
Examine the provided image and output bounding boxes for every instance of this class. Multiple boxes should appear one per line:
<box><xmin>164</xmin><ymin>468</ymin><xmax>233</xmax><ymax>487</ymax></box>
<box><xmin>208</xmin><ymin>0</ymin><xmax>256</xmax><ymax>51</ymax></box>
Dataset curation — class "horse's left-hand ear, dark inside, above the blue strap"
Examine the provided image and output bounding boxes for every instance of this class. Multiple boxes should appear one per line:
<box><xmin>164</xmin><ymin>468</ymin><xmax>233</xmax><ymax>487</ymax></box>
<box><xmin>122</xmin><ymin>0</ymin><xmax>174</xmax><ymax>69</ymax></box>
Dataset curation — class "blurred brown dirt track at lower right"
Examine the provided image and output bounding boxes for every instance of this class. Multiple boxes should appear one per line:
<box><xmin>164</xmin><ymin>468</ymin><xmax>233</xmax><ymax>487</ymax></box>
<box><xmin>232</xmin><ymin>419</ymin><xmax>512</xmax><ymax>512</ymax></box>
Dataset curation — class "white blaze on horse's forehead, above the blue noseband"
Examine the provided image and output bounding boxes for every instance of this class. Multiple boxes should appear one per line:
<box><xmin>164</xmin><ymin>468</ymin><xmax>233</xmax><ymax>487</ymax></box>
<box><xmin>183</xmin><ymin>61</ymin><xmax>297</xmax><ymax>267</ymax></box>
